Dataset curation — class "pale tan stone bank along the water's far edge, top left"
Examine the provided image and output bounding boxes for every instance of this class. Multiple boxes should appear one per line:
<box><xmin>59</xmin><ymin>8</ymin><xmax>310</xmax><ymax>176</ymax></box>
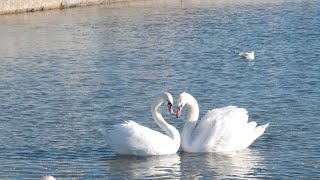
<box><xmin>0</xmin><ymin>0</ymin><xmax>130</xmax><ymax>15</ymax></box>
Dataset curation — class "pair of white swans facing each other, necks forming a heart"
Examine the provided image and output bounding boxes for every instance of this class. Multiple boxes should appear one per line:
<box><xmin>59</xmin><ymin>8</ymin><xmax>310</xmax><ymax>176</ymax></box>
<box><xmin>108</xmin><ymin>92</ymin><xmax>269</xmax><ymax>156</ymax></box>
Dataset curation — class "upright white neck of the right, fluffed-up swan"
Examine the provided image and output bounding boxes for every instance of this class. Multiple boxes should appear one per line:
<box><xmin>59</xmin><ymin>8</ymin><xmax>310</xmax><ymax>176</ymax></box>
<box><xmin>181</xmin><ymin>95</ymin><xmax>199</xmax><ymax>149</ymax></box>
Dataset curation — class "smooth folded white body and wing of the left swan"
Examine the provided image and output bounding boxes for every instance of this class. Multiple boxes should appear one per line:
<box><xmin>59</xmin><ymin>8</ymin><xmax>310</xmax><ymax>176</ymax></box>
<box><xmin>108</xmin><ymin>121</ymin><xmax>175</xmax><ymax>156</ymax></box>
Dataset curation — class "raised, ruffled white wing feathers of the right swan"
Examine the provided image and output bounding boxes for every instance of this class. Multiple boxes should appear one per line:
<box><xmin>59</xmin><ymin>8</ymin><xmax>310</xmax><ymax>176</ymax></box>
<box><xmin>193</xmin><ymin>106</ymin><xmax>266</xmax><ymax>152</ymax></box>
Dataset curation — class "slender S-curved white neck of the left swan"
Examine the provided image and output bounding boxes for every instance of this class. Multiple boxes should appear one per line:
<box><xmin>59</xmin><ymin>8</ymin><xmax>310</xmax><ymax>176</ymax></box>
<box><xmin>151</xmin><ymin>97</ymin><xmax>180</xmax><ymax>144</ymax></box>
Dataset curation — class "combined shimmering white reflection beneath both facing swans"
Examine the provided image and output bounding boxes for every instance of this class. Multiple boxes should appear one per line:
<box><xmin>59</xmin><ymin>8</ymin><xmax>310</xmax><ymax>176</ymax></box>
<box><xmin>107</xmin><ymin>149</ymin><xmax>264</xmax><ymax>179</ymax></box>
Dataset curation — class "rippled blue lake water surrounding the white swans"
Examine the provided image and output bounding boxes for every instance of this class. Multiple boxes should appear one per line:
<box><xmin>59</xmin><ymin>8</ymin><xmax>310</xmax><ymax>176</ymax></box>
<box><xmin>0</xmin><ymin>0</ymin><xmax>320</xmax><ymax>179</ymax></box>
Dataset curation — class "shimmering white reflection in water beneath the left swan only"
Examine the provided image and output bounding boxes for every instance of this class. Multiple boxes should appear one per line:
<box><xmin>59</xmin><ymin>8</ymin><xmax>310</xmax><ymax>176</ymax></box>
<box><xmin>107</xmin><ymin>154</ymin><xmax>181</xmax><ymax>179</ymax></box>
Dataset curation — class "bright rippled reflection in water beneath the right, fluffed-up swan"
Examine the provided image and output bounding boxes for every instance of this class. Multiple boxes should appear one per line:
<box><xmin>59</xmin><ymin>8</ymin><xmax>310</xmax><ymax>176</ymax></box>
<box><xmin>181</xmin><ymin>149</ymin><xmax>264</xmax><ymax>179</ymax></box>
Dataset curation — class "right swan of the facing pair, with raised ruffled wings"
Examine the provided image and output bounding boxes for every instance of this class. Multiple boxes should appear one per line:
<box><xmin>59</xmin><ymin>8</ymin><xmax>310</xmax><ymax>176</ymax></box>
<box><xmin>176</xmin><ymin>92</ymin><xmax>269</xmax><ymax>152</ymax></box>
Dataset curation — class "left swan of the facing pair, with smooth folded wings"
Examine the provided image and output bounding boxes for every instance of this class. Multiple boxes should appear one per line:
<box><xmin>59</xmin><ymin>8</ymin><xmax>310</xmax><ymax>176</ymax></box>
<box><xmin>108</xmin><ymin>92</ymin><xmax>180</xmax><ymax>156</ymax></box>
